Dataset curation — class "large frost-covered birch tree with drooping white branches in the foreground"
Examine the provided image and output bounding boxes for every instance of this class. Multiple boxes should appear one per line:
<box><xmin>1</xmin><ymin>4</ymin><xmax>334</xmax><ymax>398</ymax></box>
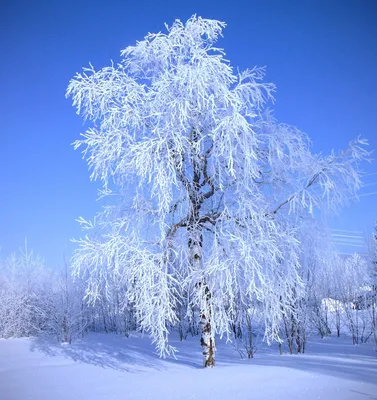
<box><xmin>67</xmin><ymin>16</ymin><xmax>368</xmax><ymax>366</ymax></box>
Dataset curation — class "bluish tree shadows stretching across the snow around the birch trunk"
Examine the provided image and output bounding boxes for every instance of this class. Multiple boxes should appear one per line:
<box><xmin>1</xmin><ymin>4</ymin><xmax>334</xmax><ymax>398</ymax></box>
<box><xmin>30</xmin><ymin>334</ymin><xmax>377</xmax><ymax>384</ymax></box>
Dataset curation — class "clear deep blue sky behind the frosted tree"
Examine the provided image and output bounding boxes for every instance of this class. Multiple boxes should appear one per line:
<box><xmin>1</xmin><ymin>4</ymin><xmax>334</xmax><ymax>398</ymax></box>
<box><xmin>0</xmin><ymin>0</ymin><xmax>377</xmax><ymax>264</ymax></box>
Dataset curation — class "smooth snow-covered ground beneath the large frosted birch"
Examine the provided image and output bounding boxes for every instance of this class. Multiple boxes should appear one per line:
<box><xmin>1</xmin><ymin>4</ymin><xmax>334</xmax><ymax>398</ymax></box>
<box><xmin>0</xmin><ymin>334</ymin><xmax>377</xmax><ymax>400</ymax></box>
